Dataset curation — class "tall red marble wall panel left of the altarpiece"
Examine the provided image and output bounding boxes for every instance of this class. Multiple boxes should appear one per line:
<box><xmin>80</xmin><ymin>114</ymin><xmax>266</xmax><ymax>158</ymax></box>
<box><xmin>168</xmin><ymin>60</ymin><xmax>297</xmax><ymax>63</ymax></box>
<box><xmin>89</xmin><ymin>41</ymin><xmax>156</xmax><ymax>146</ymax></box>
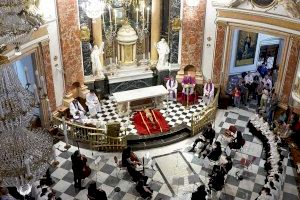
<box><xmin>56</xmin><ymin>0</ymin><xmax>84</xmax><ymax>92</ymax></box>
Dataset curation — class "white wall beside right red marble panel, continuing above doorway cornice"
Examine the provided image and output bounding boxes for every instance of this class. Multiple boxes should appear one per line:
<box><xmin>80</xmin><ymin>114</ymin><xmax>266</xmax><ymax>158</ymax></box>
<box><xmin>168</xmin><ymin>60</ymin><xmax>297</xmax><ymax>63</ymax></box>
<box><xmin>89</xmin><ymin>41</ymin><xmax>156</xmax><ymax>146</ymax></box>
<box><xmin>202</xmin><ymin>0</ymin><xmax>288</xmax><ymax>78</ymax></box>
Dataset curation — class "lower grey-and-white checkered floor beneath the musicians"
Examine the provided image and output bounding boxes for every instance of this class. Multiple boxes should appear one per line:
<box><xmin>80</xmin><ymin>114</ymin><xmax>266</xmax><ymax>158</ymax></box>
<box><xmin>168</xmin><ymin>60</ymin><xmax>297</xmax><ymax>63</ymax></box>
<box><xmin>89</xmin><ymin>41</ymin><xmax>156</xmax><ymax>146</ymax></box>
<box><xmin>51</xmin><ymin>108</ymin><xmax>298</xmax><ymax>200</ymax></box>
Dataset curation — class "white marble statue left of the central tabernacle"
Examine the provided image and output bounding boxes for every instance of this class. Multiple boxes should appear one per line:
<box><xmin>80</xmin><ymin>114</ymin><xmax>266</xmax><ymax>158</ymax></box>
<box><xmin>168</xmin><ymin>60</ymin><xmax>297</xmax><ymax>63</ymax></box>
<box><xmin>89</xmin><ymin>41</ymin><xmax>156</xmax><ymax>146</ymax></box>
<box><xmin>91</xmin><ymin>42</ymin><xmax>104</xmax><ymax>78</ymax></box>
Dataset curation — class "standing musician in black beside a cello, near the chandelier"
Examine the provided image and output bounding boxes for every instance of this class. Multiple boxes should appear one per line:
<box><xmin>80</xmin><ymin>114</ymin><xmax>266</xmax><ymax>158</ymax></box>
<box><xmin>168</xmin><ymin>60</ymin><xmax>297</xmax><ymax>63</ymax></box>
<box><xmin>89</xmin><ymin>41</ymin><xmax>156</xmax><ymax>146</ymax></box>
<box><xmin>71</xmin><ymin>150</ymin><xmax>84</xmax><ymax>190</ymax></box>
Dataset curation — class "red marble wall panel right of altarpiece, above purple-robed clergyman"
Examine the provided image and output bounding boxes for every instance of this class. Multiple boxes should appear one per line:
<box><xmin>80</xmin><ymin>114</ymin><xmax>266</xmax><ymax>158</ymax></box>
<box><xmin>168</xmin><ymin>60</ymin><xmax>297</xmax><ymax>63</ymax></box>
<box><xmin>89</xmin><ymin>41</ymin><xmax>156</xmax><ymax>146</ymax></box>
<box><xmin>181</xmin><ymin>0</ymin><xmax>206</xmax><ymax>71</ymax></box>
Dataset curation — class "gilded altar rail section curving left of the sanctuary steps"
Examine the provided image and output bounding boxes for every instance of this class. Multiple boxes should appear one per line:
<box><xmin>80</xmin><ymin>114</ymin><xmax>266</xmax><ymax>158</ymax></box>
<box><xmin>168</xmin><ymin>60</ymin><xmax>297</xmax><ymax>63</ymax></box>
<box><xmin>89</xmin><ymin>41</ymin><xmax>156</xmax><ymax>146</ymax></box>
<box><xmin>53</xmin><ymin>116</ymin><xmax>127</xmax><ymax>151</ymax></box>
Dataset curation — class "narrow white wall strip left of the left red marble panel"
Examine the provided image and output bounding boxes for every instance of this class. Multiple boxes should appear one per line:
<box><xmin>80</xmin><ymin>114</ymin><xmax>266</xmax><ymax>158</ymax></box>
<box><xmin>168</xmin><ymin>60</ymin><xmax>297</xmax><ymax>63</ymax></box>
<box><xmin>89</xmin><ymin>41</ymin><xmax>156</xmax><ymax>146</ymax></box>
<box><xmin>39</xmin><ymin>0</ymin><xmax>64</xmax><ymax>106</ymax></box>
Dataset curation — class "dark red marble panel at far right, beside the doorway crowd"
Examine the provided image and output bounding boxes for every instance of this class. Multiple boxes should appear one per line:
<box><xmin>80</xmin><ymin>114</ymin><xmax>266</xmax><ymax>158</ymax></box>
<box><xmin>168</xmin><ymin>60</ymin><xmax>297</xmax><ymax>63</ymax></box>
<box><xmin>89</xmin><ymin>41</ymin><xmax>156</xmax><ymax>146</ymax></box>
<box><xmin>280</xmin><ymin>38</ymin><xmax>300</xmax><ymax>105</ymax></box>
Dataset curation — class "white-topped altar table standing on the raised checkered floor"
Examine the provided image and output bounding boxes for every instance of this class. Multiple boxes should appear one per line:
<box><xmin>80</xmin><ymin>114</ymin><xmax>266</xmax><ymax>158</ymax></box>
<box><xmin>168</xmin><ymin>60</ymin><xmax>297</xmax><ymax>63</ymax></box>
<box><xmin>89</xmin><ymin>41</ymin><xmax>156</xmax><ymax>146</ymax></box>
<box><xmin>113</xmin><ymin>85</ymin><xmax>169</xmax><ymax>114</ymax></box>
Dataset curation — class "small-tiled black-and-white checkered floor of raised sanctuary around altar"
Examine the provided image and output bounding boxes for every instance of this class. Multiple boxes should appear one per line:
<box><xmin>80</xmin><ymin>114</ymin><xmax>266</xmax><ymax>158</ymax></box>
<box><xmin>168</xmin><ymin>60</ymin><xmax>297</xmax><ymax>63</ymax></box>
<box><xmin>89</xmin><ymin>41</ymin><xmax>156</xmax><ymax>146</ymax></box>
<box><xmin>99</xmin><ymin>96</ymin><xmax>205</xmax><ymax>134</ymax></box>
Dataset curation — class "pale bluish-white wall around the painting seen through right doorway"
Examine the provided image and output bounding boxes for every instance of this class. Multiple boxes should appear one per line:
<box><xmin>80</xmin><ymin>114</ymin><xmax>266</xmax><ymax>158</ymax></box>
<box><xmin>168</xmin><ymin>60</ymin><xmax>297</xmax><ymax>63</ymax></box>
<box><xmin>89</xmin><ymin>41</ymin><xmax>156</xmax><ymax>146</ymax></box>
<box><xmin>229</xmin><ymin>30</ymin><xmax>280</xmax><ymax>74</ymax></box>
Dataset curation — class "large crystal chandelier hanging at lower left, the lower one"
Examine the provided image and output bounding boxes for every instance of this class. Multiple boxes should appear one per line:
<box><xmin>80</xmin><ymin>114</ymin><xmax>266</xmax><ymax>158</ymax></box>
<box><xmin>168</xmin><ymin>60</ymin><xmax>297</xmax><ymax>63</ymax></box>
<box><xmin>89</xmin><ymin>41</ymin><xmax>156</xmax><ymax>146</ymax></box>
<box><xmin>0</xmin><ymin>64</ymin><xmax>53</xmax><ymax>195</ymax></box>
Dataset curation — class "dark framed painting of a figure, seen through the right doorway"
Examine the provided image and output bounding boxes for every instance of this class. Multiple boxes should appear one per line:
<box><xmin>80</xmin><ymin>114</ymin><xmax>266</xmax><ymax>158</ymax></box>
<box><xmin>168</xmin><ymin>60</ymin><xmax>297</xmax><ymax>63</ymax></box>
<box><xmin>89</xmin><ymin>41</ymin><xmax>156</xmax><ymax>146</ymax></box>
<box><xmin>235</xmin><ymin>30</ymin><xmax>258</xmax><ymax>67</ymax></box>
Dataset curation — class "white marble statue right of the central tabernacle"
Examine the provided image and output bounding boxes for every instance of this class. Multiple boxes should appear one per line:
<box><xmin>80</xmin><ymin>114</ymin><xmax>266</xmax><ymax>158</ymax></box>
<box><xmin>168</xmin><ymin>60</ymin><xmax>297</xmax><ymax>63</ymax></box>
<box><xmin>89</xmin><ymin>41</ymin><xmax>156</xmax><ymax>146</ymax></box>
<box><xmin>156</xmin><ymin>38</ymin><xmax>170</xmax><ymax>69</ymax></box>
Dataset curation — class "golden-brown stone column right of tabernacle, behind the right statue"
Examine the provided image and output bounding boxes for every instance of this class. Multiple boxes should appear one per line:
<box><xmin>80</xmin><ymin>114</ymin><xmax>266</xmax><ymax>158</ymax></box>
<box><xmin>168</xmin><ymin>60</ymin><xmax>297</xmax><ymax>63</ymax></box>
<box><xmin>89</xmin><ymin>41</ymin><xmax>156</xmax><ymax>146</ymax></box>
<box><xmin>151</xmin><ymin>0</ymin><xmax>161</xmax><ymax>62</ymax></box>
